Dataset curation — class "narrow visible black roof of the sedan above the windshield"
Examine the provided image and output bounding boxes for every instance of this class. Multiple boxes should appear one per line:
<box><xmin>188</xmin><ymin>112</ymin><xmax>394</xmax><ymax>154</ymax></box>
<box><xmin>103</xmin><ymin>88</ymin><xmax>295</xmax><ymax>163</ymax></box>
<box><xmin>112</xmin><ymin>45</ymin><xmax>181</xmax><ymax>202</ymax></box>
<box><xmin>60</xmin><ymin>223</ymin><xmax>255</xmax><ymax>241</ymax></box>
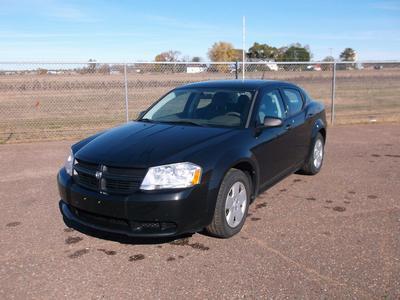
<box><xmin>179</xmin><ymin>79</ymin><xmax>296</xmax><ymax>90</ymax></box>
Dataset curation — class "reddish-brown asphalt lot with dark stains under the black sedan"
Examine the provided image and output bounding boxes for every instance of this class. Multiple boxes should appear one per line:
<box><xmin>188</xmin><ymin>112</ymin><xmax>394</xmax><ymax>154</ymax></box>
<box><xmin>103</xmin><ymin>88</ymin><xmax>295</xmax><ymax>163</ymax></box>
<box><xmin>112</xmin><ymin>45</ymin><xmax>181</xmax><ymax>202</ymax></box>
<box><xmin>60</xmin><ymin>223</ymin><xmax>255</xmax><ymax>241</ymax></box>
<box><xmin>0</xmin><ymin>124</ymin><xmax>400</xmax><ymax>299</ymax></box>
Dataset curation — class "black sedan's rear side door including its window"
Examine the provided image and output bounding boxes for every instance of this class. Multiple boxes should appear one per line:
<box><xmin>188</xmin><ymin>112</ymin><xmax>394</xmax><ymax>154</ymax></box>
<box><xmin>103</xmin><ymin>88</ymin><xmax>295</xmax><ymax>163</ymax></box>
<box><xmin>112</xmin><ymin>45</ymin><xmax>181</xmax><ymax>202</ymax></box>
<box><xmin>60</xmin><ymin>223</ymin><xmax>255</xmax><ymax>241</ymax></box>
<box><xmin>280</xmin><ymin>86</ymin><xmax>309</xmax><ymax>166</ymax></box>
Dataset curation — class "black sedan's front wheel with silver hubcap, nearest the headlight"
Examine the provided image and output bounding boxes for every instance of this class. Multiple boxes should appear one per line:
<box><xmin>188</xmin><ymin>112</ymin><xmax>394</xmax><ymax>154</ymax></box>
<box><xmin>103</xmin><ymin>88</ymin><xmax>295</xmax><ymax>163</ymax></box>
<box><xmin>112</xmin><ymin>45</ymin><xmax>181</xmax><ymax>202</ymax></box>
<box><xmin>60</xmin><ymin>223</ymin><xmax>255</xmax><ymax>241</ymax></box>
<box><xmin>206</xmin><ymin>169</ymin><xmax>251</xmax><ymax>238</ymax></box>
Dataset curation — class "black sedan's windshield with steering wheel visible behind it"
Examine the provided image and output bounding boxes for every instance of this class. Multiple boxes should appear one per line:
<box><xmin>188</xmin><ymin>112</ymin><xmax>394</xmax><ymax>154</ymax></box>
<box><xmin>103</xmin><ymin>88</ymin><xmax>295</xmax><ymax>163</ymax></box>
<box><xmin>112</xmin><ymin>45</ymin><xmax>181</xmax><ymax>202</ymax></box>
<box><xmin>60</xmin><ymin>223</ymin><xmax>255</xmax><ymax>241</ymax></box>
<box><xmin>140</xmin><ymin>88</ymin><xmax>254</xmax><ymax>127</ymax></box>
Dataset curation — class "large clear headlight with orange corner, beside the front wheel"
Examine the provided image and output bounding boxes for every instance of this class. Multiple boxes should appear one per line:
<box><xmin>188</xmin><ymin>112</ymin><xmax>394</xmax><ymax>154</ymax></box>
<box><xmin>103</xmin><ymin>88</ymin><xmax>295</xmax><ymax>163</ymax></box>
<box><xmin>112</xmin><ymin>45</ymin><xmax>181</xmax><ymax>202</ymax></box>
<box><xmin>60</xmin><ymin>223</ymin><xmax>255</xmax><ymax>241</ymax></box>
<box><xmin>140</xmin><ymin>162</ymin><xmax>202</xmax><ymax>190</ymax></box>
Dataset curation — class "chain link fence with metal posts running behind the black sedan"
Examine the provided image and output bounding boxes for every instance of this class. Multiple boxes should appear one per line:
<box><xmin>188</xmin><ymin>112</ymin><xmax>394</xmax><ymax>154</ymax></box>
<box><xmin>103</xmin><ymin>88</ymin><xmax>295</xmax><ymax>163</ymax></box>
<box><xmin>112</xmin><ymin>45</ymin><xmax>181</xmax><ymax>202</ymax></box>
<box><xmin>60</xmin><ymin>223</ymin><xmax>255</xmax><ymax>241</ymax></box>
<box><xmin>0</xmin><ymin>62</ymin><xmax>400</xmax><ymax>143</ymax></box>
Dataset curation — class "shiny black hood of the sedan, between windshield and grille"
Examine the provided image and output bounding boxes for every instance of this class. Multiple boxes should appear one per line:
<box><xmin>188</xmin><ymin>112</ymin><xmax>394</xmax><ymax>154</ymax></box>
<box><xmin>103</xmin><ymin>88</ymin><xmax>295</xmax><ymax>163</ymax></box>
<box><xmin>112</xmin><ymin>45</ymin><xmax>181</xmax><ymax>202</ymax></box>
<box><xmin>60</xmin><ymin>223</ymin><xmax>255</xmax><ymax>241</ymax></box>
<box><xmin>73</xmin><ymin>122</ymin><xmax>234</xmax><ymax>168</ymax></box>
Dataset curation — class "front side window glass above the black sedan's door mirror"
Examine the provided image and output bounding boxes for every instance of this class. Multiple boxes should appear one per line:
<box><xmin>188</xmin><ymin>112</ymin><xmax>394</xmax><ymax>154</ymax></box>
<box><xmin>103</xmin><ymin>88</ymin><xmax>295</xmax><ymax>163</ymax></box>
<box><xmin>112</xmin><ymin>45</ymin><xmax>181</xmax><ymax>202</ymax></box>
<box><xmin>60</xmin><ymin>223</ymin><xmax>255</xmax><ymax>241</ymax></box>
<box><xmin>257</xmin><ymin>90</ymin><xmax>285</xmax><ymax>124</ymax></box>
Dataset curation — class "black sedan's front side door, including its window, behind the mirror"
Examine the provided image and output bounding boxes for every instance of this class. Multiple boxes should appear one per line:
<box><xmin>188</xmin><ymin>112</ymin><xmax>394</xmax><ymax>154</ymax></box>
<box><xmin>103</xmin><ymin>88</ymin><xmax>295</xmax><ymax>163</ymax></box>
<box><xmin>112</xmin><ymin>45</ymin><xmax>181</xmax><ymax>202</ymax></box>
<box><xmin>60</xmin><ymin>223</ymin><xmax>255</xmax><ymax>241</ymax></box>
<box><xmin>253</xmin><ymin>88</ymin><xmax>290</xmax><ymax>187</ymax></box>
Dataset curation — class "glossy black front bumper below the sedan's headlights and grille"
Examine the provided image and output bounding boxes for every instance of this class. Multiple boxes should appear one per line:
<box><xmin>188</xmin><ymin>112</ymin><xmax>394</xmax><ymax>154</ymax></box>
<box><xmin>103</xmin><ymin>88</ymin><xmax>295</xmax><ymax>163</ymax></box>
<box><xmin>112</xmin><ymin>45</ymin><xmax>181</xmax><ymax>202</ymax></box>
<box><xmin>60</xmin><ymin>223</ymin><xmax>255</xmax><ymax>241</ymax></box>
<box><xmin>57</xmin><ymin>169</ymin><xmax>212</xmax><ymax>237</ymax></box>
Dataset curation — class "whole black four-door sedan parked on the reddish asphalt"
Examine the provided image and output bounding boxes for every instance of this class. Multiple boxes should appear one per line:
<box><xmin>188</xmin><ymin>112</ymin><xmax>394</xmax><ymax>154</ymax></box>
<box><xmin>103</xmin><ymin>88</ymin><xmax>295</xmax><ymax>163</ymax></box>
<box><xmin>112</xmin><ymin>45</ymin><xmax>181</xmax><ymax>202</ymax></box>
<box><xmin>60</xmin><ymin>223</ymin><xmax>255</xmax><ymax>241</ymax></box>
<box><xmin>58</xmin><ymin>80</ymin><xmax>326</xmax><ymax>238</ymax></box>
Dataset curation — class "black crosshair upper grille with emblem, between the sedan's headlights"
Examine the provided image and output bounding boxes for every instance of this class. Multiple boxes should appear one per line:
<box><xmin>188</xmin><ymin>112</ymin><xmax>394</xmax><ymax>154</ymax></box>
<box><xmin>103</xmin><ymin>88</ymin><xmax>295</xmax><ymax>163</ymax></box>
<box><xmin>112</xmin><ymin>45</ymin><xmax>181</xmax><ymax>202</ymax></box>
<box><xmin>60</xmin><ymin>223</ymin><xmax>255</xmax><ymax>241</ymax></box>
<box><xmin>73</xmin><ymin>159</ymin><xmax>146</xmax><ymax>194</ymax></box>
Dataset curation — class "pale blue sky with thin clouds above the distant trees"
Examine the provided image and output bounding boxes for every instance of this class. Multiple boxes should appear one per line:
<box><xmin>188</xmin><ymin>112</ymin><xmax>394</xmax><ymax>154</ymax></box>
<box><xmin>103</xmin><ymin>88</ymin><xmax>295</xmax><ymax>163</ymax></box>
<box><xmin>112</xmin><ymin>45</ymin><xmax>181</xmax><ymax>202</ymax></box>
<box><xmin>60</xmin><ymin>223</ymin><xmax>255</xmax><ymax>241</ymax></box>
<box><xmin>0</xmin><ymin>0</ymin><xmax>400</xmax><ymax>61</ymax></box>
